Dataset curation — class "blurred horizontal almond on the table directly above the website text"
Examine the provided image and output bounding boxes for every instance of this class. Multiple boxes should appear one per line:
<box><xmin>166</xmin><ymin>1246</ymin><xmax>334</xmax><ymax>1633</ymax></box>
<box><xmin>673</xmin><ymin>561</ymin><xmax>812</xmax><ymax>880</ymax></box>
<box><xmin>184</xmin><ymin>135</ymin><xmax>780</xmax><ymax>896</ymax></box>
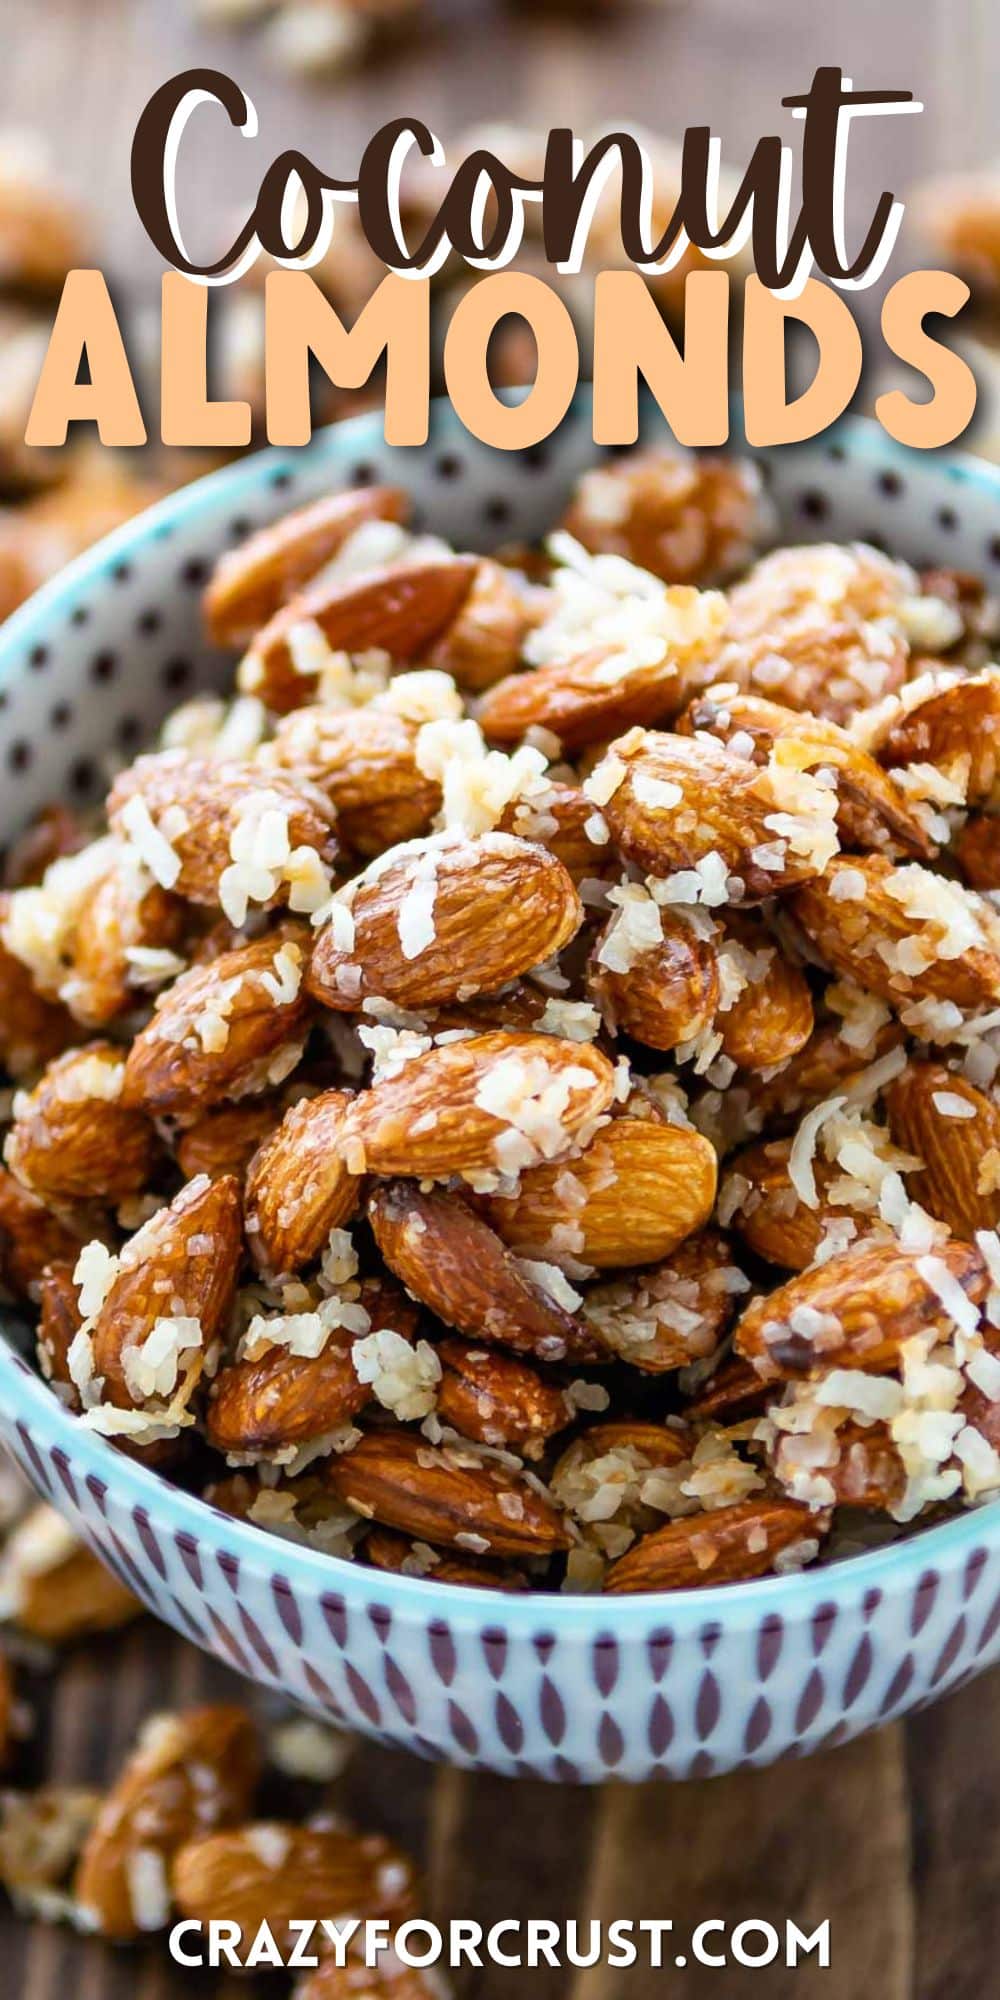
<box><xmin>172</xmin><ymin>1820</ymin><xmax>416</xmax><ymax>1954</ymax></box>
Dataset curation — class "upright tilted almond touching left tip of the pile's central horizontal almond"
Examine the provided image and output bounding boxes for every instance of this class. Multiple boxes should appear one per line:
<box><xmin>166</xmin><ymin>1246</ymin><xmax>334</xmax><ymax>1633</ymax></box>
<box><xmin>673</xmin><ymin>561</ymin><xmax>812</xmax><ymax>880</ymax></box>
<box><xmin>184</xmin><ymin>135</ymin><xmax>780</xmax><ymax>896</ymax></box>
<box><xmin>246</xmin><ymin>1090</ymin><xmax>362</xmax><ymax>1274</ymax></box>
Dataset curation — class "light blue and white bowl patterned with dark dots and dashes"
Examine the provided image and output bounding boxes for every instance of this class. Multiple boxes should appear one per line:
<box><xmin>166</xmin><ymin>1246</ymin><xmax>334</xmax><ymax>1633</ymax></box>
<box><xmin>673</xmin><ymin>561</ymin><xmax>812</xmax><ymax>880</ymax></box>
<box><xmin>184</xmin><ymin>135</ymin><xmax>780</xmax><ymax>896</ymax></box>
<box><xmin>0</xmin><ymin>398</ymin><xmax>1000</xmax><ymax>1782</ymax></box>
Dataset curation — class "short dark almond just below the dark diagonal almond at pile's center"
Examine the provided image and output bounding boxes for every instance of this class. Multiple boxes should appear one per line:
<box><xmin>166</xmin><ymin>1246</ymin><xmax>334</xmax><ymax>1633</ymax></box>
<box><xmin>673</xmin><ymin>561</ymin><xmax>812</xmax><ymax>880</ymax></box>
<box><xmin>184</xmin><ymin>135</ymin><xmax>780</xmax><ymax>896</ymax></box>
<box><xmin>438</xmin><ymin>1336</ymin><xmax>570</xmax><ymax>1458</ymax></box>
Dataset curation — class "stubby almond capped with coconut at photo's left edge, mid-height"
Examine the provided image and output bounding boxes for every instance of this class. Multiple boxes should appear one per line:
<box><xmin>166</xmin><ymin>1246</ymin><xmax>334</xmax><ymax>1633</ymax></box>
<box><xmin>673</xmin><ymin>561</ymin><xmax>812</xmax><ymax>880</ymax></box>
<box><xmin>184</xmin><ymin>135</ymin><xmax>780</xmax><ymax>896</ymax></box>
<box><xmin>4</xmin><ymin>1042</ymin><xmax>160</xmax><ymax>1202</ymax></box>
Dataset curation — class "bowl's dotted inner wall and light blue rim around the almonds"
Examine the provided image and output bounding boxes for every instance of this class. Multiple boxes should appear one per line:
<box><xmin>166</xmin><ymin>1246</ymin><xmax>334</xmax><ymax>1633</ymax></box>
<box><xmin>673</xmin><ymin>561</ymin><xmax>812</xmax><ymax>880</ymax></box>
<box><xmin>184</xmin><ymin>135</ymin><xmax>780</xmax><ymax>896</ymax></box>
<box><xmin>0</xmin><ymin>396</ymin><xmax>1000</xmax><ymax>1628</ymax></box>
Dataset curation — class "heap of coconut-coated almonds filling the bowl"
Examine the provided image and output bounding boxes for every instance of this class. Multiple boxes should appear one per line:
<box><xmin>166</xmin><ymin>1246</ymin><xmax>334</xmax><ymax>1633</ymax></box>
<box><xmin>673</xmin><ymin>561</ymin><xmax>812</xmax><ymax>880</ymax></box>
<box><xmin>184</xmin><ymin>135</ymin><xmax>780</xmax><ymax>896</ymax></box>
<box><xmin>0</xmin><ymin>452</ymin><xmax>1000</xmax><ymax>1592</ymax></box>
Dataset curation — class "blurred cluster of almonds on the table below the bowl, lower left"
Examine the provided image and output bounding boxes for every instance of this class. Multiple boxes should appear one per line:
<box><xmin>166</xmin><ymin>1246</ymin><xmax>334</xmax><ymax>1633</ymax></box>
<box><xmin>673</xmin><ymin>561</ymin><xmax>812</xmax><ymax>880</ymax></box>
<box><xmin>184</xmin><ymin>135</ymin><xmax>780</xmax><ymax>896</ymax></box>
<box><xmin>0</xmin><ymin>1704</ymin><xmax>444</xmax><ymax>2000</ymax></box>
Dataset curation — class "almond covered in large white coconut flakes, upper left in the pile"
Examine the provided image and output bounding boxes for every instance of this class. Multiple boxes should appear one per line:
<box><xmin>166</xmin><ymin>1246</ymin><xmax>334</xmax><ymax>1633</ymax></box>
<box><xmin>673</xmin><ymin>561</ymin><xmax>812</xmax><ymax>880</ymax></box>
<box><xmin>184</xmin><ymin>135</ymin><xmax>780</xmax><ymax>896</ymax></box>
<box><xmin>108</xmin><ymin>750</ymin><xmax>336</xmax><ymax>908</ymax></box>
